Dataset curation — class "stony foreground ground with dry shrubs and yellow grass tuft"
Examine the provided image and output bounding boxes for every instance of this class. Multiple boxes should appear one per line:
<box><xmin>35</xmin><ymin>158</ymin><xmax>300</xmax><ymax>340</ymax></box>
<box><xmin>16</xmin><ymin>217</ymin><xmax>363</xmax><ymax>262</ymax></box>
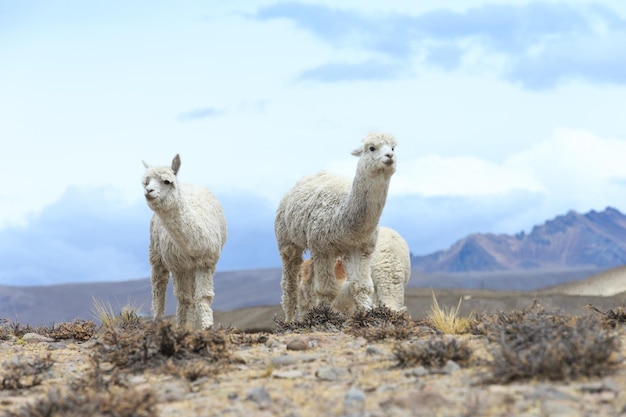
<box><xmin>0</xmin><ymin>295</ymin><xmax>626</xmax><ymax>417</ymax></box>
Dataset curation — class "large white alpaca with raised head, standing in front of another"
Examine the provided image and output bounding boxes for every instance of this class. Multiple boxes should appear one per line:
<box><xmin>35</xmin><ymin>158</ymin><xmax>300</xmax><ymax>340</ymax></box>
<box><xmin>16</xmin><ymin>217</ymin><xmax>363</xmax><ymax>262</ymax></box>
<box><xmin>274</xmin><ymin>133</ymin><xmax>396</xmax><ymax>321</ymax></box>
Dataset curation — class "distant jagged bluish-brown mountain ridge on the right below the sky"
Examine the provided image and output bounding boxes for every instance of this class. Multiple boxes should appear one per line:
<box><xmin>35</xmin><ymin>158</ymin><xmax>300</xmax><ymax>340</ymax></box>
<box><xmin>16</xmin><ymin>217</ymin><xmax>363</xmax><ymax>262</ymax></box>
<box><xmin>411</xmin><ymin>207</ymin><xmax>626</xmax><ymax>273</ymax></box>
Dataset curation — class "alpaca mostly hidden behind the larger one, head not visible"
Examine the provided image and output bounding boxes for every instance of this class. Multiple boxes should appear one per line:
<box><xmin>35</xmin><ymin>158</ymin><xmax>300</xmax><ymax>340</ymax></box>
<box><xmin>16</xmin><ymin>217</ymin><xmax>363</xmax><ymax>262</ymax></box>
<box><xmin>298</xmin><ymin>226</ymin><xmax>411</xmax><ymax>315</ymax></box>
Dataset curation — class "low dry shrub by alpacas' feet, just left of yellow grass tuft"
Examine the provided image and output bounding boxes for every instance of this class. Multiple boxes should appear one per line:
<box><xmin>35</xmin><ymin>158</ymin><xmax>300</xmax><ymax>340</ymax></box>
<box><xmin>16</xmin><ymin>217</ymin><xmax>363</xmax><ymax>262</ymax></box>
<box><xmin>346</xmin><ymin>305</ymin><xmax>417</xmax><ymax>341</ymax></box>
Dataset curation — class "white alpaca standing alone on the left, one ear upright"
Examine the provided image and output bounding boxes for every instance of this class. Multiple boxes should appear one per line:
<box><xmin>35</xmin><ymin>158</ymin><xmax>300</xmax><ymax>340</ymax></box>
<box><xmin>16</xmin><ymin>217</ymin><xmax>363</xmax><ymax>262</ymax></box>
<box><xmin>143</xmin><ymin>155</ymin><xmax>226</xmax><ymax>328</ymax></box>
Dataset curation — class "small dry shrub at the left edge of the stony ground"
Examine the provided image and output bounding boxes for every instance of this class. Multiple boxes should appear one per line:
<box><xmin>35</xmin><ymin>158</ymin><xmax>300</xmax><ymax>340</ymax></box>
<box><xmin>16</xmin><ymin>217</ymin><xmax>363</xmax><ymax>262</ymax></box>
<box><xmin>0</xmin><ymin>353</ymin><xmax>54</xmax><ymax>390</ymax></box>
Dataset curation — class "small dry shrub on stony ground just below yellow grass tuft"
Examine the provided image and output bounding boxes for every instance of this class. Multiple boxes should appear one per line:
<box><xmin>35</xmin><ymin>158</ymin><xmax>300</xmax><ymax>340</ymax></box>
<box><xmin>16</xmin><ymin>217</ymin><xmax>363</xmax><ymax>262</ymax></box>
<box><xmin>393</xmin><ymin>336</ymin><xmax>472</xmax><ymax>368</ymax></box>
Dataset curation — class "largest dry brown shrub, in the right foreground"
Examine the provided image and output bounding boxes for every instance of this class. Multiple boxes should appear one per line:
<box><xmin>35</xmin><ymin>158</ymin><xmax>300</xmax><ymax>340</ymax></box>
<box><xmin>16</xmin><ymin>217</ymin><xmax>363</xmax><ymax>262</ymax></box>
<box><xmin>486</xmin><ymin>302</ymin><xmax>620</xmax><ymax>383</ymax></box>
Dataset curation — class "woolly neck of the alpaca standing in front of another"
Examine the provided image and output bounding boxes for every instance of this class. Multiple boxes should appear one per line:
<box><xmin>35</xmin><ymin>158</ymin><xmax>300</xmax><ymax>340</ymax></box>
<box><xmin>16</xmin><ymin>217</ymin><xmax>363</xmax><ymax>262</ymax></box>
<box><xmin>337</xmin><ymin>169</ymin><xmax>391</xmax><ymax>236</ymax></box>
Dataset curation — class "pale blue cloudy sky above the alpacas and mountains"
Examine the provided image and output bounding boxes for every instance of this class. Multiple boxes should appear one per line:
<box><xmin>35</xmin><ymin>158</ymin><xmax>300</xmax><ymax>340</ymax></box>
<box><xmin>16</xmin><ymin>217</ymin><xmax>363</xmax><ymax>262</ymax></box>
<box><xmin>0</xmin><ymin>0</ymin><xmax>626</xmax><ymax>285</ymax></box>
